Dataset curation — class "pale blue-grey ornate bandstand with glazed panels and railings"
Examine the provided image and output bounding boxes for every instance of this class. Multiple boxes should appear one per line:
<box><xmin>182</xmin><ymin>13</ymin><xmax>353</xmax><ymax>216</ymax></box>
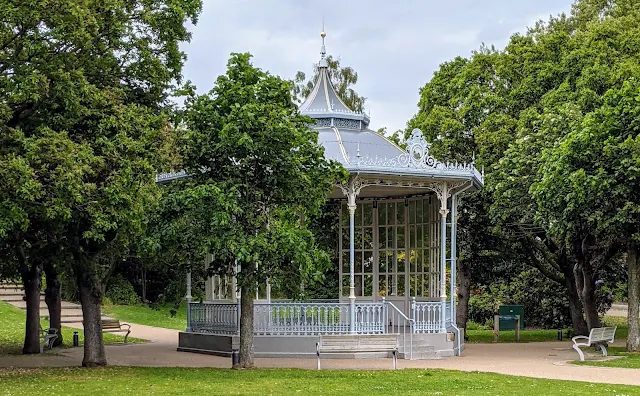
<box><xmin>166</xmin><ymin>32</ymin><xmax>484</xmax><ymax>359</ymax></box>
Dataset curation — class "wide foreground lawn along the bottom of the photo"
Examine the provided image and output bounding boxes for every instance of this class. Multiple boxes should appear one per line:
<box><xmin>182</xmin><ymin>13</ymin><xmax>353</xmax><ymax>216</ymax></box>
<box><xmin>0</xmin><ymin>367</ymin><xmax>640</xmax><ymax>396</ymax></box>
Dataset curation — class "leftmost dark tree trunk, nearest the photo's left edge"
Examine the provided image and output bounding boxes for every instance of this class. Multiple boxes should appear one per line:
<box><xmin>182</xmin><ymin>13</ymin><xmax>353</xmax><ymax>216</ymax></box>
<box><xmin>21</xmin><ymin>264</ymin><xmax>42</xmax><ymax>354</ymax></box>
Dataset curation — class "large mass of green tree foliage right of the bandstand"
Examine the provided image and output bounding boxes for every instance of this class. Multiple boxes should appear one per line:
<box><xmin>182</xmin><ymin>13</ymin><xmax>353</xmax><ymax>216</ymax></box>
<box><xmin>409</xmin><ymin>0</ymin><xmax>640</xmax><ymax>340</ymax></box>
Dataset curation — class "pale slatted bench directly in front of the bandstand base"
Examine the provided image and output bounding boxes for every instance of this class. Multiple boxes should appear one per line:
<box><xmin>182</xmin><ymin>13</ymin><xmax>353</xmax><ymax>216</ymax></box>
<box><xmin>316</xmin><ymin>334</ymin><xmax>398</xmax><ymax>370</ymax></box>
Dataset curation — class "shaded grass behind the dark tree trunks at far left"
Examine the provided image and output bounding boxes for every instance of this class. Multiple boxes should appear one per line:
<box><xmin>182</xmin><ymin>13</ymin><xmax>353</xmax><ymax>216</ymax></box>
<box><xmin>0</xmin><ymin>301</ymin><xmax>144</xmax><ymax>355</ymax></box>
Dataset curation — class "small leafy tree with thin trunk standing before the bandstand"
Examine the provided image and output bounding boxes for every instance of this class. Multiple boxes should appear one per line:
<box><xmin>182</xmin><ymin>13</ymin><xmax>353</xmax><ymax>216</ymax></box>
<box><xmin>183</xmin><ymin>54</ymin><xmax>340</xmax><ymax>367</ymax></box>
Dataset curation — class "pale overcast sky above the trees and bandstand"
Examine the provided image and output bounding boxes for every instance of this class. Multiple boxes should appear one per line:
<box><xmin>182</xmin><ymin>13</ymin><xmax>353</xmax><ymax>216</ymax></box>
<box><xmin>183</xmin><ymin>0</ymin><xmax>572</xmax><ymax>132</ymax></box>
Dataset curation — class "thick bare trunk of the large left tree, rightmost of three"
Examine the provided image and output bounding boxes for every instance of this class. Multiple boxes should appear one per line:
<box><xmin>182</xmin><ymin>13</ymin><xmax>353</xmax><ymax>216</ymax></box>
<box><xmin>77</xmin><ymin>274</ymin><xmax>107</xmax><ymax>367</ymax></box>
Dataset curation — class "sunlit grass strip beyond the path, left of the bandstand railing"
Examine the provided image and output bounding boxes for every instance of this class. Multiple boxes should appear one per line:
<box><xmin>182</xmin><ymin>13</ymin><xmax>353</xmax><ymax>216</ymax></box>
<box><xmin>102</xmin><ymin>302</ymin><xmax>187</xmax><ymax>331</ymax></box>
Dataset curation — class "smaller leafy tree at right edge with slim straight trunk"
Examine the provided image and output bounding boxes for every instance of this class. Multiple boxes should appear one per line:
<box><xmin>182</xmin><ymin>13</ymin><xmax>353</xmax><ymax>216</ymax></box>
<box><xmin>533</xmin><ymin>79</ymin><xmax>640</xmax><ymax>351</ymax></box>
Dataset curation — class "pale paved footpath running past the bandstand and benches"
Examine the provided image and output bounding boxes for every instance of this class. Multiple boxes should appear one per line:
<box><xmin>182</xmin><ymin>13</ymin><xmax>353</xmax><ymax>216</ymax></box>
<box><xmin>0</xmin><ymin>324</ymin><xmax>640</xmax><ymax>385</ymax></box>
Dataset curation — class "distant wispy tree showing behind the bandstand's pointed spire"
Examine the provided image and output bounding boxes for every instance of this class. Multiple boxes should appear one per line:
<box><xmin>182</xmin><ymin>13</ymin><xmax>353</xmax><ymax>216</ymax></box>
<box><xmin>291</xmin><ymin>55</ymin><xmax>367</xmax><ymax>112</ymax></box>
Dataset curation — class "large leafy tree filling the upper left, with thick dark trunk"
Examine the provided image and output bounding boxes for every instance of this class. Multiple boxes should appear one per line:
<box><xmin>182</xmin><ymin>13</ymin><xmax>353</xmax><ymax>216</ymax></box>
<box><xmin>0</xmin><ymin>0</ymin><xmax>201</xmax><ymax>366</ymax></box>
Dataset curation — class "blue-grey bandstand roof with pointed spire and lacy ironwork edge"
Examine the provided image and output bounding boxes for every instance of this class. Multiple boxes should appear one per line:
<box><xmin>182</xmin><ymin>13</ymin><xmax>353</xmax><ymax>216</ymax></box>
<box><xmin>156</xmin><ymin>32</ymin><xmax>484</xmax><ymax>198</ymax></box>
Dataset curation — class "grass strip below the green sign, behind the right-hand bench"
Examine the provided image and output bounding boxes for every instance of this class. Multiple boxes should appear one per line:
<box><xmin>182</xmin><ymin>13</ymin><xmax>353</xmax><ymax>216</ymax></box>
<box><xmin>467</xmin><ymin>316</ymin><xmax>628</xmax><ymax>343</ymax></box>
